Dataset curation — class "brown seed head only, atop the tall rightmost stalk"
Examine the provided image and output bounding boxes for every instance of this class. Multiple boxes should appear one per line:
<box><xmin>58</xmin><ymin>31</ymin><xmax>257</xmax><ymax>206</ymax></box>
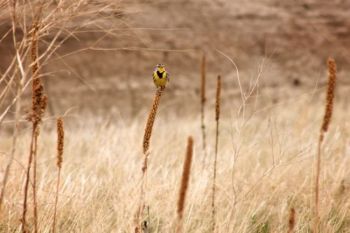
<box><xmin>321</xmin><ymin>58</ymin><xmax>337</xmax><ymax>132</ymax></box>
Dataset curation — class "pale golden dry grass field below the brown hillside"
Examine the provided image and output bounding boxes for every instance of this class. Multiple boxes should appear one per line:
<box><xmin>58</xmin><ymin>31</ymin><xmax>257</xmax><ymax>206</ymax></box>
<box><xmin>1</xmin><ymin>93</ymin><xmax>350</xmax><ymax>233</ymax></box>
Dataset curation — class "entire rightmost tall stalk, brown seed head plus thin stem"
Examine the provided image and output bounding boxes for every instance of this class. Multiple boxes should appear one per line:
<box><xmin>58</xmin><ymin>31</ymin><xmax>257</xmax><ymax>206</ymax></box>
<box><xmin>314</xmin><ymin>58</ymin><xmax>336</xmax><ymax>233</ymax></box>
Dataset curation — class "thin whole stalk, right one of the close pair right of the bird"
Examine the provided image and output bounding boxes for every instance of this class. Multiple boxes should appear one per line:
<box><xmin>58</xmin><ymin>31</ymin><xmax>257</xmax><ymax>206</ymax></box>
<box><xmin>211</xmin><ymin>75</ymin><xmax>221</xmax><ymax>232</ymax></box>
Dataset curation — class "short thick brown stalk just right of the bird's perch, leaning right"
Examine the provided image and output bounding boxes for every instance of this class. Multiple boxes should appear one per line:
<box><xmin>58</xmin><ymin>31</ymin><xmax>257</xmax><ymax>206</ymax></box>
<box><xmin>176</xmin><ymin>136</ymin><xmax>193</xmax><ymax>233</ymax></box>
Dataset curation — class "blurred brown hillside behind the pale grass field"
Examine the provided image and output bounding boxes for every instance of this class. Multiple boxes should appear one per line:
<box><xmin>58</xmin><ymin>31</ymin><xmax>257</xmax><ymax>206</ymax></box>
<box><xmin>0</xmin><ymin>0</ymin><xmax>350</xmax><ymax>118</ymax></box>
